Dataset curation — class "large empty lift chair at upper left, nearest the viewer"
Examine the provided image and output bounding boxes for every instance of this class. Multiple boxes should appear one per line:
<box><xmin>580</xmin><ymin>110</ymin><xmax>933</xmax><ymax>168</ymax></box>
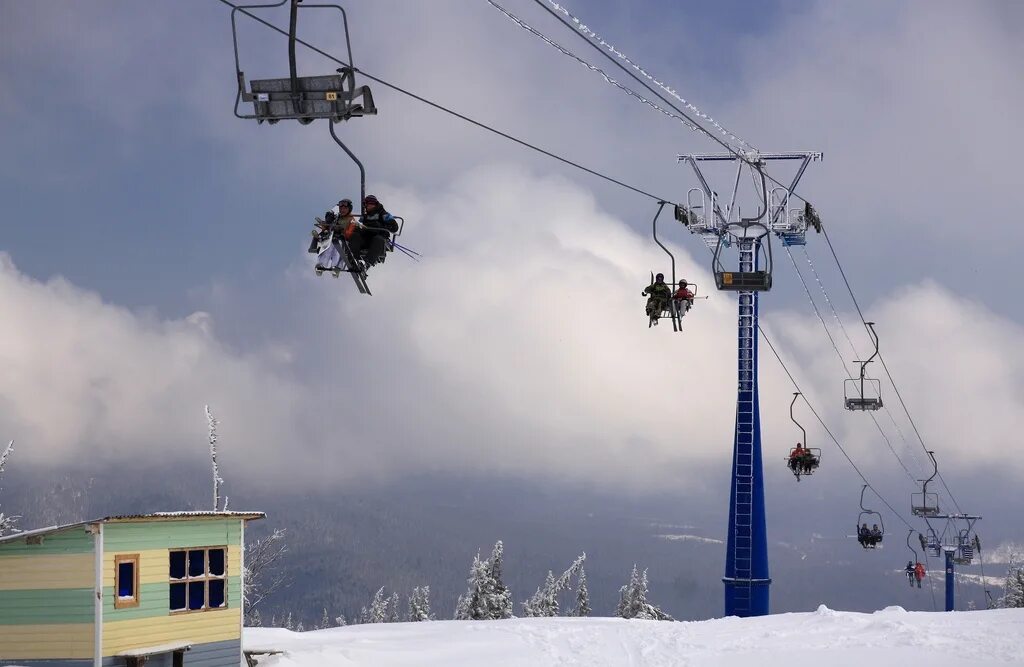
<box><xmin>231</xmin><ymin>0</ymin><xmax>377</xmax><ymax>125</ymax></box>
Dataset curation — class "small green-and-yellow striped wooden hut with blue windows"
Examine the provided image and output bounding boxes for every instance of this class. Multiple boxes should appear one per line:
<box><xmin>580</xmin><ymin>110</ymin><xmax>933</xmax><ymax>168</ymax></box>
<box><xmin>0</xmin><ymin>511</ymin><xmax>264</xmax><ymax>667</ymax></box>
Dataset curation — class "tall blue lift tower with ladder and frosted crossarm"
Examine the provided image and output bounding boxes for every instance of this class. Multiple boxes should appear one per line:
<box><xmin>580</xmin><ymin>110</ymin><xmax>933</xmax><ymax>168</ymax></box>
<box><xmin>679</xmin><ymin>152</ymin><xmax>821</xmax><ymax>617</ymax></box>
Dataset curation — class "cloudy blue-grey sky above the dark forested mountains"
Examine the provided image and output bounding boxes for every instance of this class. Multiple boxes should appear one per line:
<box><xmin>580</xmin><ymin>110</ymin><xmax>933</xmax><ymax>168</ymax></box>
<box><xmin>0</xmin><ymin>0</ymin><xmax>1024</xmax><ymax>536</ymax></box>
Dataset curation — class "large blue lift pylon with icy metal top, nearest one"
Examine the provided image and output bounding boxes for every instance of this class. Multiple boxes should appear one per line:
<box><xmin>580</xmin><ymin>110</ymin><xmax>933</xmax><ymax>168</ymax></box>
<box><xmin>676</xmin><ymin>153</ymin><xmax>821</xmax><ymax>617</ymax></box>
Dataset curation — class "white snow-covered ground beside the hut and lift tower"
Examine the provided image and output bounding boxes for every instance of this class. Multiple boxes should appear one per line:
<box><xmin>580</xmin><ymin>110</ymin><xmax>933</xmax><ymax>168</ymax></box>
<box><xmin>245</xmin><ymin>607</ymin><xmax>1024</xmax><ymax>667</ymax></box>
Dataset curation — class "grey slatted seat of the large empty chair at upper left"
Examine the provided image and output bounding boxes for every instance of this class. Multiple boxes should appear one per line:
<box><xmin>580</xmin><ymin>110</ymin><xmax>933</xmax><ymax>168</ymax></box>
<box><xmin>240</xmin><ymin>73</ymin><xmax>377</xmax><ymax>123</ymax></box>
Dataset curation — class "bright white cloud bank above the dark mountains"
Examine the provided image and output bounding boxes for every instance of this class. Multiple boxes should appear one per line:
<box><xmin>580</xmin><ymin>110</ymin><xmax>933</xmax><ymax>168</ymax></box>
<box><xmin>0</xmin><ymin>166</ymin><xmax>1024</xmax><ymax>499</ymax></box>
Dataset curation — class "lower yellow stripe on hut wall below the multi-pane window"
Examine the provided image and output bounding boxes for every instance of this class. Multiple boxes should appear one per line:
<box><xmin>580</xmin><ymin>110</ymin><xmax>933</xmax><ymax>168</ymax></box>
<box><xmin>103</xmin><ymin>609</ymin><xmax>242</xmax><ymax>656</ymax></box>
